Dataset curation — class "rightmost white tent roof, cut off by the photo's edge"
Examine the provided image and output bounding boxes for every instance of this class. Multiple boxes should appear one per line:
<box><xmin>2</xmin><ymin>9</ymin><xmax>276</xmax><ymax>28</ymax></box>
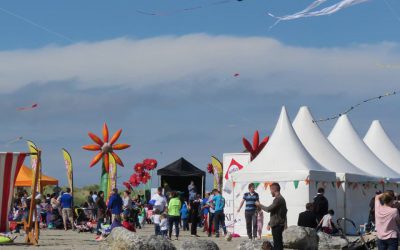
<box><xmin>364</xmin><ymin>120</ymin><xmax>400</xmax><ymax>173</ymax></box>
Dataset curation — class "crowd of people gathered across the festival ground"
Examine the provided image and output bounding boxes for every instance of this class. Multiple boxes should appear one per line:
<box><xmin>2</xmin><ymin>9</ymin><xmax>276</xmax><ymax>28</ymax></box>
<box><xmin>9</xmin><ymin>182</ymin><xmax>400</xmax><ymax>250</ymax></box>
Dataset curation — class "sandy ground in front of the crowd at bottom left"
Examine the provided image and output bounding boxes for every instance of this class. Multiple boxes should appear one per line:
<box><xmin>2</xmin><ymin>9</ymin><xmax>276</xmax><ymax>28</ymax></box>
<box><xmin>0</xmin><ymin>225</ymin><xmax>253</xmax><ymax>250</ymax></box>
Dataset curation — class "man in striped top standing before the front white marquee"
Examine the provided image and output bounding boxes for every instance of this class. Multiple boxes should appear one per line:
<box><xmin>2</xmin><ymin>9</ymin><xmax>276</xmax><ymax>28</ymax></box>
<box><xmin>237</xmin><ymin>183</ymin><xmax>260</xmax><ymax>240</ymax></box>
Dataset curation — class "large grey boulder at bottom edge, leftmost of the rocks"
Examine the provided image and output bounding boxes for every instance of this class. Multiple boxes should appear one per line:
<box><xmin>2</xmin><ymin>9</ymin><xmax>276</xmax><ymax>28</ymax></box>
<box><xmin>100</xmin><ymin>227</ymin><xmax>176</xmax><ymax>250</ymax></box>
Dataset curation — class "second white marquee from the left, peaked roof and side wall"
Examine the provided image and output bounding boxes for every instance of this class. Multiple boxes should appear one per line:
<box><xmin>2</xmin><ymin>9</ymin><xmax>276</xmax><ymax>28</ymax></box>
<box><xmin>293</xmin><ymin>107</ymin><xmax>379</xmax><ymax>233</ymax></box>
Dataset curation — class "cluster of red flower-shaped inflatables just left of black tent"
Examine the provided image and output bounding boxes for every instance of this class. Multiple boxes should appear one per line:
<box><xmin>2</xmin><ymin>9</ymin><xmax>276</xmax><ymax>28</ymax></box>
<box><xmin>123</xmin><ymin>159</ymin><xmax>157</xmax><ymax>189</ymax></box>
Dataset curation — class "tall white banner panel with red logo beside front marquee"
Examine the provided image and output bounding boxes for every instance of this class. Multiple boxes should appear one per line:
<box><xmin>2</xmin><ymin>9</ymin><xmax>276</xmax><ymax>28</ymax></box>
<box><xmin>222</xmin><ymin>153</ymin><xmax>250</xmax><ymax>235</ymax></box>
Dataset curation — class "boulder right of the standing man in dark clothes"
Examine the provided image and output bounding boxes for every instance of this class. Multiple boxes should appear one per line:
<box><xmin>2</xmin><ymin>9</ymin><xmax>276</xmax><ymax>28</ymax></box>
<box><xmin>283</xmin><ymin>226</ymin><xmax>318</xmax><ymax>250</ymax></box>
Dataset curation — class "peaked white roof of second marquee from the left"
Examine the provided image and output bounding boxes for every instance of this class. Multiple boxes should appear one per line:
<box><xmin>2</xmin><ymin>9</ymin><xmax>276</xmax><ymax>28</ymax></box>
<box><xmin>293</xmin><ymin>106</ymin><xmax>376</xmax><ymax>180</ymax></box>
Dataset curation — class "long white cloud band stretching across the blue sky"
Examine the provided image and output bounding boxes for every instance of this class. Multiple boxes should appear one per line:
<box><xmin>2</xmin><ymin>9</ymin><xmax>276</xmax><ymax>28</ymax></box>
<box><xmin>0</xmin><ymin>34</ymin><xmax>400</xmax><ymax>94</ymax></box>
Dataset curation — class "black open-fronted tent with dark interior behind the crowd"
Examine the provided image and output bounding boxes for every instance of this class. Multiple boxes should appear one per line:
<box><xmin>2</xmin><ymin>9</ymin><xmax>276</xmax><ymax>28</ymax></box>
<box><xmin>157</xmin><ymin>157</ymin><xmax>206</xmax><ymax>198</ymax></box>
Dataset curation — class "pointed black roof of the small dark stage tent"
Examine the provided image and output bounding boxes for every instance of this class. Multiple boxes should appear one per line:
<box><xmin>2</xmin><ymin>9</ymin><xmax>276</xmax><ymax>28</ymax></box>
<box><xmin>157</xmin><ymin>157</ymin><xmax>206</xmax><ymax>176</ymax></box>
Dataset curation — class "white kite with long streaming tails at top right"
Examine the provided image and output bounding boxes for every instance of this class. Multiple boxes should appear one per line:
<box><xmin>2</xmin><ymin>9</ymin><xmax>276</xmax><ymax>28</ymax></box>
<box><xmin>268</xmin><ymin>0</ymin><xmax>369</xmax><ymax>29</ymax></box>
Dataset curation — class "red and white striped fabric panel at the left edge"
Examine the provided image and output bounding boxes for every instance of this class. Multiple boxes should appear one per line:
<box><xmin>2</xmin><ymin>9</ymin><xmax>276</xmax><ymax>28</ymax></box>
<box><xmin>0</xmin><ymin>152</ymin><xmax>26</xmax><ymax>232</ymax></box>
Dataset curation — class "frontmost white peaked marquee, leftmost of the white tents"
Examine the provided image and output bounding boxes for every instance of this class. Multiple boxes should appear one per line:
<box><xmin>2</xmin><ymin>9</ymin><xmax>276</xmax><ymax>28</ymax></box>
<box><xmin>232</xmin><ymin>107</ymin><xmax>336</xmax><ymax>229</ymax></box>
